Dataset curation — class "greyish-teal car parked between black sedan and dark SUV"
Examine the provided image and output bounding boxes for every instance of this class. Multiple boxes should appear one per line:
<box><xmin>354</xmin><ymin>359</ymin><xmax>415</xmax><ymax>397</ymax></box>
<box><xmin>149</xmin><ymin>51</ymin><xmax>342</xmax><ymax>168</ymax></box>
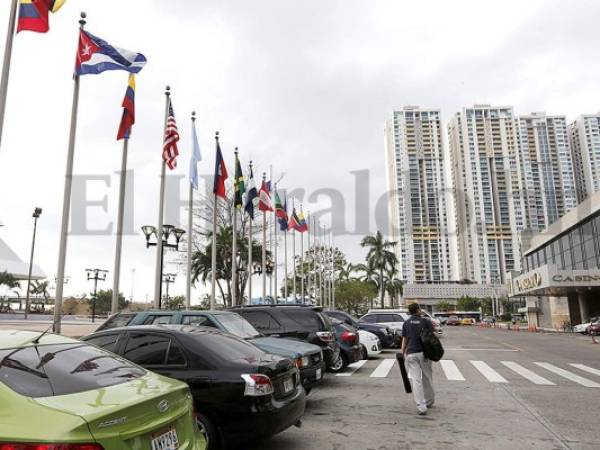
<box><xmin>98</xmin><ymin>310</ymin><xmax>325</xmax><ymax>393</ymax></box>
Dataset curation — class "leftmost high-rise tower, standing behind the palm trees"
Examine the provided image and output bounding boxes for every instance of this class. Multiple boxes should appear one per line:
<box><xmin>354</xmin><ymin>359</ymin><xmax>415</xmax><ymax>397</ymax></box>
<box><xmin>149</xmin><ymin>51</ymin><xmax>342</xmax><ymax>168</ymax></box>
<box><xmin>385</xmin><ymin>107</ymin><xmax>458</xmax><ymax>283</ymax></box>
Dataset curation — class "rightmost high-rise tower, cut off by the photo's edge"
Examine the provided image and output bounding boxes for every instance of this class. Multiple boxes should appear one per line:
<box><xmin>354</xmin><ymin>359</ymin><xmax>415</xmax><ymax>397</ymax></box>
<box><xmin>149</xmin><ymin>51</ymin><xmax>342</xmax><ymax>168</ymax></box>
<box><xmin>569</xmin><ymin>113</ymin><xmax>600</xmax><ymax>202</ymax></box>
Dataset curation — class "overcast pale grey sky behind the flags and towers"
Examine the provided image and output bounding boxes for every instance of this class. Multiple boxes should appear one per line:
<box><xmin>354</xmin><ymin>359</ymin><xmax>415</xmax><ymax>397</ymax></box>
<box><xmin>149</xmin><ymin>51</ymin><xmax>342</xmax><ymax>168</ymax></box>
<box><xmin>0</xmin><ymin>0</ymin><xmax>600</xmax><ymax>300</ymax></box>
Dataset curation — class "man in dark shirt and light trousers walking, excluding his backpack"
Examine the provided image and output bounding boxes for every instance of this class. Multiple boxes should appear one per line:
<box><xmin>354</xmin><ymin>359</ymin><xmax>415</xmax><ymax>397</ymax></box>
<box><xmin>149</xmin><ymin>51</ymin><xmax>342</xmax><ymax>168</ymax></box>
<box><xmin>402</xmin><ymin>303</ymin><xmax>435</xmax><ymax>416</ymax></box>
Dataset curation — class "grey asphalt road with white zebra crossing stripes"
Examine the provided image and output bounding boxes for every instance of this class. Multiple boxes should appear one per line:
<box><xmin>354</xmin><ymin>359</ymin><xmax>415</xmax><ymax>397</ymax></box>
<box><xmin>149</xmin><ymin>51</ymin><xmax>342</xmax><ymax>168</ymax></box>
<box><xmin>256</xmin><ymin>327</ymin><xmax>600</xmax><ymax>450</ymax></box>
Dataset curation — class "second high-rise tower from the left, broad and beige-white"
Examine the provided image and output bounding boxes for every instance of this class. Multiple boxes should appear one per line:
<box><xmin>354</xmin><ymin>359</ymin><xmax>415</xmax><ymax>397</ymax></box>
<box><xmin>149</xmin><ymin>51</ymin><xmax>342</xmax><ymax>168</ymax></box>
<box><xmin>448</xmin><ymin>105</ymin><xmax>526</xmax><ymax>283</ymax></box>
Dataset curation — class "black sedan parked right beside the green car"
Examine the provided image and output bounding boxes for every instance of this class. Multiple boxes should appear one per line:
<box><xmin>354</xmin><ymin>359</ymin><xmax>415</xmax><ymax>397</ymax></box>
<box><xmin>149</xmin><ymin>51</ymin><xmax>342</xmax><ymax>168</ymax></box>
<box><xmin>83</xmin><ymin>325</ymin><xmax>306</xmax><ymax>450</ymax></box>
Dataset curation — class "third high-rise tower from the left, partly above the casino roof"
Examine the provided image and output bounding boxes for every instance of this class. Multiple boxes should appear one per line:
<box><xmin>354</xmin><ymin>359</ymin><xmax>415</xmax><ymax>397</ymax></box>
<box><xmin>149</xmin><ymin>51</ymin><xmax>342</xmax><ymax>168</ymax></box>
<box><xmin>519</xmin><ymin>113</ymin><xmax>578</xmax><ymax>232</ymax></box>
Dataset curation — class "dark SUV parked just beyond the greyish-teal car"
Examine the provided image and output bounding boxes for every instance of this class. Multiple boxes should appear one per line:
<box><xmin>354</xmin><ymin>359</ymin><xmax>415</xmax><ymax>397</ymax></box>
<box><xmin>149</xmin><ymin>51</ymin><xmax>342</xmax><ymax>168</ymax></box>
<box><xmin>231</xmin><ymin>305</ymin><xmax>340</xmax><ymax>368</ymax></box>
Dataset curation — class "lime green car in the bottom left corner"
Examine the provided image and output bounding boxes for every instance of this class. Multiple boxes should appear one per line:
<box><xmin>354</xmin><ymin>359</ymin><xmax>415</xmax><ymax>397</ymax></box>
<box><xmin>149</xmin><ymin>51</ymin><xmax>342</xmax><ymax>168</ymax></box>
<box><xmin>0</xmin><ymin>330</ymin><xmax>205</xmax><ymax>450</ymax></box>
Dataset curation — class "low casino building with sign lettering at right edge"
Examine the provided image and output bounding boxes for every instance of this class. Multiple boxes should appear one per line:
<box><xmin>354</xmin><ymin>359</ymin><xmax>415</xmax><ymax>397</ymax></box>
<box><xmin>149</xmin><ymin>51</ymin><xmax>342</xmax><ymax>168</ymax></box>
<box><xmin>507</xmin><ymin>192</ymin><xmax>600</xmax><ymax>328</ymax></box>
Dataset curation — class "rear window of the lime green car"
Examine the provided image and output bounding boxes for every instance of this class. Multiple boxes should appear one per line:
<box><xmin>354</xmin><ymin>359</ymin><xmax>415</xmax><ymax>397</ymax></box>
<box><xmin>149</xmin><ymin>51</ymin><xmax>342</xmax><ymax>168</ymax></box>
<box><xmin>0</xmin><ymin>344</ymin><xmax>146</xmax><ymax>397</ymax></box>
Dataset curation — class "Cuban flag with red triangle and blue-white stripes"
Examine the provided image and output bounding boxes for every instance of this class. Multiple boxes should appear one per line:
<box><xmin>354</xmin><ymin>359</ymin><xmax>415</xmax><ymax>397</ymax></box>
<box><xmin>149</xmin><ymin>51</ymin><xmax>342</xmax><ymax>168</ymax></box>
<box><xmin>75</xmin><ymin>30</ymin><xmax>146</xmax><ymax>75</ymax></box>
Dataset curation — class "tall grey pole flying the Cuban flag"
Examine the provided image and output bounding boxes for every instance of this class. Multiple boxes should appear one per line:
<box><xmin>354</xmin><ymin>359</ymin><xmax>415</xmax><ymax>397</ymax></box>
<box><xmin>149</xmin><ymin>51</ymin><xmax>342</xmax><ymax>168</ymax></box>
<box><xmin>53</xmin><ymin>12</ymin><xmax>86</xmax><ymax>334</ymax></box>
